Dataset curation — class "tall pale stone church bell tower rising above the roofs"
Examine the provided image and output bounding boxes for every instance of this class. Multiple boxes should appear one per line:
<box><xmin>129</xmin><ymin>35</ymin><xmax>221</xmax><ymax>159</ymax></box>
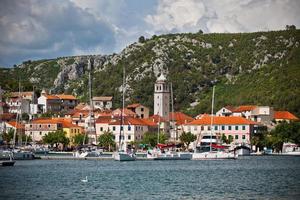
<box><xmin>154</xmin><ymin>74</ymin><xmax>170</xmax><ymax>120</ymax></box>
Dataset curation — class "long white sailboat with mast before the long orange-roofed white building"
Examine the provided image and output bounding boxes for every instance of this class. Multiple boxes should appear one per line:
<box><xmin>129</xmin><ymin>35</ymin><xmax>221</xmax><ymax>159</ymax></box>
<box><xmin>192</xmin><ymin>86</ymin><xmax>238</xmax><ymax>160</ymax></box>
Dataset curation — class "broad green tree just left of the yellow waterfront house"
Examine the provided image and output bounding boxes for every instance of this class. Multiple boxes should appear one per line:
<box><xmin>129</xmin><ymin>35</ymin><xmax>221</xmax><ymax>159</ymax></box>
<box><xmin>43</xmin><ymin>130</ymin><xmax>70</xmax><ymax>148</ymax></box>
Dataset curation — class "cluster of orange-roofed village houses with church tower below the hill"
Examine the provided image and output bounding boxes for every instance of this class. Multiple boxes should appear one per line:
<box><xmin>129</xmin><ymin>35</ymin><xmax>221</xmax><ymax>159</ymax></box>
<box><xmin>0</xmin><ymin>74</ymin><xmax>299</xmax><ymax>150</ymax></box>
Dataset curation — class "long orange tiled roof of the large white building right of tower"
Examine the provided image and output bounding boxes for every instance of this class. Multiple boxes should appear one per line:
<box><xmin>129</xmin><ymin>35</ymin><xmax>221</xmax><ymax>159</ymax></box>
<box><xmin>187</xmin><ymin>115</ymin><xmax>257</xmax><ymax>125</ymax></box>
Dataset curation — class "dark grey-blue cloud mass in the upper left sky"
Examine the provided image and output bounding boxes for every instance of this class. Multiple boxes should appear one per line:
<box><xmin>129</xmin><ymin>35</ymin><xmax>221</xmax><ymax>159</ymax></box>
<box><xmin>0</xmin><ymin>0</ymin><xmax>116</xmax><ymax>65</ymax></box>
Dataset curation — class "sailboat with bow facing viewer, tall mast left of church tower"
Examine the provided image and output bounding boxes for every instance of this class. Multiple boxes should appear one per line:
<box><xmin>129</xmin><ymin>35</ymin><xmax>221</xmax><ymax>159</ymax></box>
<box><xmin>114</xmin><ymin>67</ymin><xmax>136</xmax><ymax>161</ymax></box>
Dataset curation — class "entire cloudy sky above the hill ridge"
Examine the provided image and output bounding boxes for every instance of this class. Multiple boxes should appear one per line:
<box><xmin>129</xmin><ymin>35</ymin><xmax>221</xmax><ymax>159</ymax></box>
<box><xmin>0</xmin><ymin>0</ymin><xmax>300</xmax><ymax>67</ymax></box>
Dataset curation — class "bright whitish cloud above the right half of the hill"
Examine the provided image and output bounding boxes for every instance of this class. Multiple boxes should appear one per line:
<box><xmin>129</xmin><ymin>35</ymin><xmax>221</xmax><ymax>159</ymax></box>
<box><xmin>145</xmin><ymin>0</ymin><xmax>300</xmax><ymax>33</ymax></box>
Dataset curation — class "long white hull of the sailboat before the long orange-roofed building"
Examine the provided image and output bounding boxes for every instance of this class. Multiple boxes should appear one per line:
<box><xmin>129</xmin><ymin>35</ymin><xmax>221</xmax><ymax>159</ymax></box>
<box><xmin>192</xmin><ymin>152</ymin><xmax>238</xmax><ymax>160</ymax></box>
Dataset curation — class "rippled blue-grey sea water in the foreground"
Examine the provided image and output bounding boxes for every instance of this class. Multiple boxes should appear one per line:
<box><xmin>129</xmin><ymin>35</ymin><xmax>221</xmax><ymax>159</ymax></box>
<box><xmin>0</xmin><ymin>156</ymin><xmax>300</xmax><ymax>199</ymax></box>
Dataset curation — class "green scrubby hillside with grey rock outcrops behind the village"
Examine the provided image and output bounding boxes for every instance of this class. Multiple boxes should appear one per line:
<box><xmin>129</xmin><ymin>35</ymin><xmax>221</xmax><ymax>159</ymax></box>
<box><xmin>0</xmin><ymin>30</ymin><xmax>300</xmax><ymax>116</ymax></box>
